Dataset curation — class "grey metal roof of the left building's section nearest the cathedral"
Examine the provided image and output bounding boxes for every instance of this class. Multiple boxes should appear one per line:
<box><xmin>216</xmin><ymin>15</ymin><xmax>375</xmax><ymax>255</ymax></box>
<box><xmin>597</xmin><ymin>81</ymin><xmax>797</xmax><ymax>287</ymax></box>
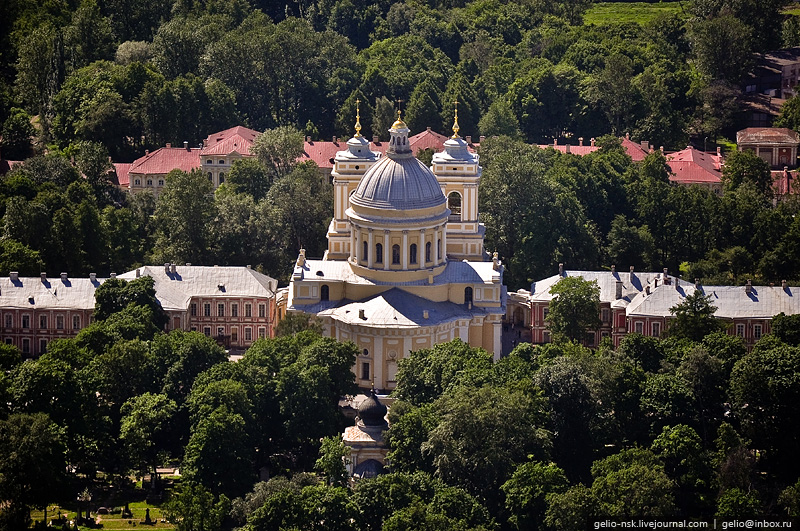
<box><xmin>117</xmin><ymin>265</ymin><xmax>278</xmax><ymax>310</ymax></box>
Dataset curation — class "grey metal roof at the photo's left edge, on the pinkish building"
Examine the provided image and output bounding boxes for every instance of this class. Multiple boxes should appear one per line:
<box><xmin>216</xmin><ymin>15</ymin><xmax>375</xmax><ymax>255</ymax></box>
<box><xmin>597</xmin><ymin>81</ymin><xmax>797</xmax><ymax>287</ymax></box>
<box><xmin>0</xmin><ymin>277</ymin><xmax>105</xmax><ymax>310</ymax></box>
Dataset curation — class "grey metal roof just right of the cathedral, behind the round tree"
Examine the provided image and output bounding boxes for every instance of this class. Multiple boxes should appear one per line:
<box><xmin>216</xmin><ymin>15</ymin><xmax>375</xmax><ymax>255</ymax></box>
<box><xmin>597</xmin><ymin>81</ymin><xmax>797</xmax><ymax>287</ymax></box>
<box><xmin>531</xmin><ymin>271</ymin><xmax>690</xmax><ymax>307</ymax></box>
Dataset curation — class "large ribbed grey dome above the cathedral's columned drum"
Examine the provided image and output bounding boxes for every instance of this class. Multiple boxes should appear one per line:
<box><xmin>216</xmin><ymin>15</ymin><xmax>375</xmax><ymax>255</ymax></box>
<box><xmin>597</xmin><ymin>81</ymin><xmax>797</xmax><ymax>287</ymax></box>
<box><xmin>350</xmin><ymin>156</ymin><xmax>446</xmax><ymax>210</ymax></box>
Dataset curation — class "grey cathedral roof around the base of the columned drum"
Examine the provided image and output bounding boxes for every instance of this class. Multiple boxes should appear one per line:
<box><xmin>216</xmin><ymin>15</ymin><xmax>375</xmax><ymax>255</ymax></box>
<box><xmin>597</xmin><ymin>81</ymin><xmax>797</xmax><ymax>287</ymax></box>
<box><xmin>294</xmin><ymin>260</ymin><xmax>499</xmax><ymax>286</ymax></box>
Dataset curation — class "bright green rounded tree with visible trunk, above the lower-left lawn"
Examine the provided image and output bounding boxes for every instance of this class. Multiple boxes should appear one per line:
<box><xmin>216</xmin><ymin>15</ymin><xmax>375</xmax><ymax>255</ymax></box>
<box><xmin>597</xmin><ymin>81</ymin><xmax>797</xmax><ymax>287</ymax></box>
<box><xmin>119</xmin><ymin>393</ymin><xmax>177</xmax><ymax>488</ymax></box>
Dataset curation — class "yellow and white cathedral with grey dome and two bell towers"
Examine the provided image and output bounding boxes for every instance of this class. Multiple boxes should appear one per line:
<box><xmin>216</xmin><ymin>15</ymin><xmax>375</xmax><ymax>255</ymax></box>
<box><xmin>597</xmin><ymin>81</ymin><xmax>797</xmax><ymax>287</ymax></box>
<box><xmin>286</xmin><ymin>107</ymin><xmax>507</xmax><ymax>390</ymax></box>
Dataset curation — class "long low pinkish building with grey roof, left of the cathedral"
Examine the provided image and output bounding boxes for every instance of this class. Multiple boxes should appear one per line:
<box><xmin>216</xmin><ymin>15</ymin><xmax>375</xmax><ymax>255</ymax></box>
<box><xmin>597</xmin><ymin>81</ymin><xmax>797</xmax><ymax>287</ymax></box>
<box><xmin>0</xmin><ymin>264</ymin><xmax>277</xmax><ymax>356</ymax></box>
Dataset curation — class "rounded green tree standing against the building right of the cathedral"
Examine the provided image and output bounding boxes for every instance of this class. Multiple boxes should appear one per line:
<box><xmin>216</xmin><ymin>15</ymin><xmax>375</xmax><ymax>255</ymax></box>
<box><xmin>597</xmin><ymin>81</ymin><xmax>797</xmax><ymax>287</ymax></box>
<box><xmin>545</xmin><ymin>277</ymin><xmax>600</xmax><ymax>342</ymax></box>
